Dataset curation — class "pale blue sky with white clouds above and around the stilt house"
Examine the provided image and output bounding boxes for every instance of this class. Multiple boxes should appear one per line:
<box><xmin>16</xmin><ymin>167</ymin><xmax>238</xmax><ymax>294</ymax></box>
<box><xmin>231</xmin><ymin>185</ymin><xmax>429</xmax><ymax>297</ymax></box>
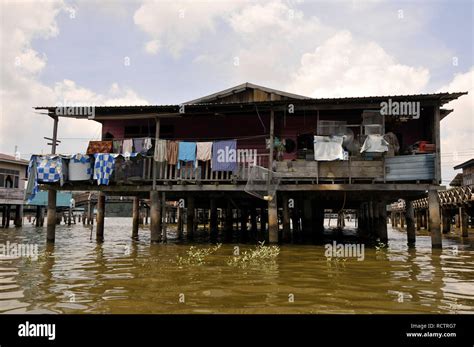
<box><xmin>0</xmin><ymin>0</ymin><xmax>474</xmax><ymax>184</ymax></box>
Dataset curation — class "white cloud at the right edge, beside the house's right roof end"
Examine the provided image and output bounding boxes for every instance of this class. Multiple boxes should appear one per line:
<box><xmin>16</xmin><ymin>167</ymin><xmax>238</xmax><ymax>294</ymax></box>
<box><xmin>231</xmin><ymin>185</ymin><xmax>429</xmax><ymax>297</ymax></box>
<box><xmin>439</xmin><ymin>67</ymin><xmax>474</xmax><ymax>184</ymax></box>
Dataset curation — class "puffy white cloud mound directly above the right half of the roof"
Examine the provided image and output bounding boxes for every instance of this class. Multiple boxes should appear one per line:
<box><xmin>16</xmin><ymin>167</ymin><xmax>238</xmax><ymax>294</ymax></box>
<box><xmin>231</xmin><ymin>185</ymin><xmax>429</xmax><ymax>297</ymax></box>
<box><xmin>288</xmin><ymin>31</ymin><xmax>430</xmax><ymax>97</ymax></box>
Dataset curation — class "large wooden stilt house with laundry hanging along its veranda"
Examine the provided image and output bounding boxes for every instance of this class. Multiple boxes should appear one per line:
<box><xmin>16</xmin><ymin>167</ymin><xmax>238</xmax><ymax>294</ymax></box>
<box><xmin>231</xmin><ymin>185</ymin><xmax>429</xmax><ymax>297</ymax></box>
<box><xmin>30</xmin><ymin>83</ymin><xmax>466</xmax><ymax>248</ymax></box>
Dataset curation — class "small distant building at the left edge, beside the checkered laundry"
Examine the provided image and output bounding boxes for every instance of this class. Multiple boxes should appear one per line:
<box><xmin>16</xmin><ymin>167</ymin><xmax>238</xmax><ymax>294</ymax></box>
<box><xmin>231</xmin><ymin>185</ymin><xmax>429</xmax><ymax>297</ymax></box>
<box><xmin>0</xmin><ymin>153</ymin><xmax>28</xmax><ymax>228</ymax></box>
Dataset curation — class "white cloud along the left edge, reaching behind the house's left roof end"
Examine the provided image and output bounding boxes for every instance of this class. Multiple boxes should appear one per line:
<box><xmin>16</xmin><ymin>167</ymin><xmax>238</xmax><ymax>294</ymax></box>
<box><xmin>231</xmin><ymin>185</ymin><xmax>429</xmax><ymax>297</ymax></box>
<box><xmin>0</xmin><ymin>1</ymin><xmax>147</xmax><ymax>158</ymax></box>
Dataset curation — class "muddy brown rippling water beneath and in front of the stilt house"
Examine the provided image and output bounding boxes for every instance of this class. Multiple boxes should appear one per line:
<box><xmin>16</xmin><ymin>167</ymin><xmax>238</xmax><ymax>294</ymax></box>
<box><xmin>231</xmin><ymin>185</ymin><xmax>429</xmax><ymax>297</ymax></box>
<box><xmin>0</xmin><ymin>218</ymin><xmax>474</xmax><ymax>314</ymax></box>
